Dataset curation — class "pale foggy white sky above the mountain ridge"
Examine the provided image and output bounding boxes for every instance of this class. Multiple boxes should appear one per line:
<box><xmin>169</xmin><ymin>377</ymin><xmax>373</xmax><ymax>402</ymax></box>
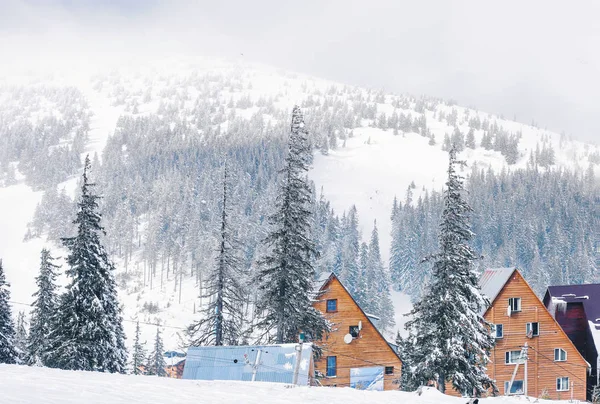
<box><xmin>0</xmin><ymin>0</ymin><xmax>600</xmax><ymax>143</ymax></box>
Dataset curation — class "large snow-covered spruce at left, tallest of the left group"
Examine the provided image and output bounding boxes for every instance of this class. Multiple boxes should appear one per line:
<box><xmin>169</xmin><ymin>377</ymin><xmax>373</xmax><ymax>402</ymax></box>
<box><xmin>49</xmin><ymin>157</ymin><xmax>127</xmax><ymax>373</ymax></box>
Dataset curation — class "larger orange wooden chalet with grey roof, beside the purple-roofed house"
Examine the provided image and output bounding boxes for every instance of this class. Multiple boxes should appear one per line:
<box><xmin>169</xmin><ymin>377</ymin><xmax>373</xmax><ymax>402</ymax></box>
<box><xmin>464</xmin><ymin>268</ymin><xmax>589</xmax><ymax>400</ymax></box>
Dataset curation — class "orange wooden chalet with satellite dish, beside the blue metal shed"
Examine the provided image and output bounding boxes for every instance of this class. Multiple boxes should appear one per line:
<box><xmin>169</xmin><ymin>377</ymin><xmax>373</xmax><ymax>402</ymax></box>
<box><xmin>314</xmin><ymin>273</ymin><xmax>402</xmax><ymax>390</ymax></box>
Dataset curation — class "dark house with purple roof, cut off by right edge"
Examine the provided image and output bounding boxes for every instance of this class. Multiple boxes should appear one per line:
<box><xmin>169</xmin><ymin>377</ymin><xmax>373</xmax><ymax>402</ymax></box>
<box><xmin>544</xmin><ymin>284</ymin><xmax>600</xmax><ymax>401</ymax></box>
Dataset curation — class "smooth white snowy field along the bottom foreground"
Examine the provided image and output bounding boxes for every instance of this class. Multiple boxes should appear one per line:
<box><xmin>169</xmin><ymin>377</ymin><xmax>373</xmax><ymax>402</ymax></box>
<box><xmin>0</xmin><ymin>365</ymin><xmax>580</xmax><ymax>404</ymax></box>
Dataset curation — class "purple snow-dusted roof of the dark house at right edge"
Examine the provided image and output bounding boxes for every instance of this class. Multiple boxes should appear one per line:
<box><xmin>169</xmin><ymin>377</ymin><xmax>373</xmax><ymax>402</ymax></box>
<box><xmin>544</xmin><ymin>283</ymin><xmax>600</xmax><ymax>353</ymax></box>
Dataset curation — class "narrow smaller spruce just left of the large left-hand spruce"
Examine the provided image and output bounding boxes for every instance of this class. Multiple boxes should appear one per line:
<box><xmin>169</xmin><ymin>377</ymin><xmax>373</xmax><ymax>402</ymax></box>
<box><xmin>27</xmin><ymin>248</ymin><xmax>59</xmax><ymax>366</ymax></box>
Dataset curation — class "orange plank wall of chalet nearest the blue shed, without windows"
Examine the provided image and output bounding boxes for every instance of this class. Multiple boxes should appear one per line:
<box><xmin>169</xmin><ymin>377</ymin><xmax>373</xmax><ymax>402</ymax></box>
<box><xmin>314</xmin><ymin>278</ymin><xmax>402</xmax><ymax>390</ymax></box>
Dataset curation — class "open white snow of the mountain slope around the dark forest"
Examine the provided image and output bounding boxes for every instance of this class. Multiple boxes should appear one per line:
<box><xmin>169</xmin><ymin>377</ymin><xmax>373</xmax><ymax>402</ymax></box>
<box><xmin>0</xmin><ymin>56</ymin><xmax>600</xmax><ymax>347</ymax></box>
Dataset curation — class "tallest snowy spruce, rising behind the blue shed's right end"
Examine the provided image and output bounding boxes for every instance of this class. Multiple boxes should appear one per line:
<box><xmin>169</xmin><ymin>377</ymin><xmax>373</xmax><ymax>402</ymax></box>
<box><xmin>257</xmin><ymin>106</ymin><xmax>328</xmax><ymax>343</ymax></box>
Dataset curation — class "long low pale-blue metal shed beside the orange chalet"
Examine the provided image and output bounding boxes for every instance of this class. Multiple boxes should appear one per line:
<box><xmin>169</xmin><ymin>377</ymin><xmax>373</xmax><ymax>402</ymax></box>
<box><xmin>183</xmin><ymin>343</ymin><xmax>313</xmax><ymax>385</ymax></box>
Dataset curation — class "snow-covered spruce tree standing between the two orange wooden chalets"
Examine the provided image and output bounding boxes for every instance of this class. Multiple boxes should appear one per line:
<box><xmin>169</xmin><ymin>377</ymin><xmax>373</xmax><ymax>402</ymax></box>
<box><xmin>403</xmin><ymin>148</ymin><xmax>496</xmax><ymax>395</ymax></box>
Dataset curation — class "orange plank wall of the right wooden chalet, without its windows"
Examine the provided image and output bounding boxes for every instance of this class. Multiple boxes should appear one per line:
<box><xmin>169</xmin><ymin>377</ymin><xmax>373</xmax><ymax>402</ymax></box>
<box><xmin>485</xmin><ymin>272</ymin><xmax>587</xmax><ymax>400</ymax></box>
